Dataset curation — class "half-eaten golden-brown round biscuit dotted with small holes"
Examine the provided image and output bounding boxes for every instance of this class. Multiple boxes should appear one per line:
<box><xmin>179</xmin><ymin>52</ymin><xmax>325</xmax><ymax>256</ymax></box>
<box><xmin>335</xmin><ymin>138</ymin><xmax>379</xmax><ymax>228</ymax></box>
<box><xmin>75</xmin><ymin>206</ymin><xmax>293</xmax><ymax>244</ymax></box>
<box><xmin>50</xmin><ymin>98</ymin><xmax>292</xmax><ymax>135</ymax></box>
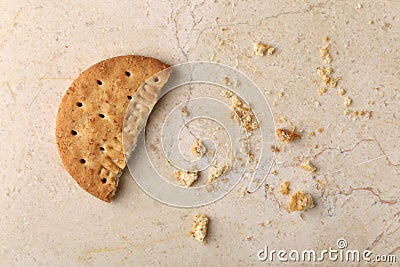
<box><xmin>56</xmin><ymin>55</ymin><xmax>169</xmax><ymax>202</ymax></box>
